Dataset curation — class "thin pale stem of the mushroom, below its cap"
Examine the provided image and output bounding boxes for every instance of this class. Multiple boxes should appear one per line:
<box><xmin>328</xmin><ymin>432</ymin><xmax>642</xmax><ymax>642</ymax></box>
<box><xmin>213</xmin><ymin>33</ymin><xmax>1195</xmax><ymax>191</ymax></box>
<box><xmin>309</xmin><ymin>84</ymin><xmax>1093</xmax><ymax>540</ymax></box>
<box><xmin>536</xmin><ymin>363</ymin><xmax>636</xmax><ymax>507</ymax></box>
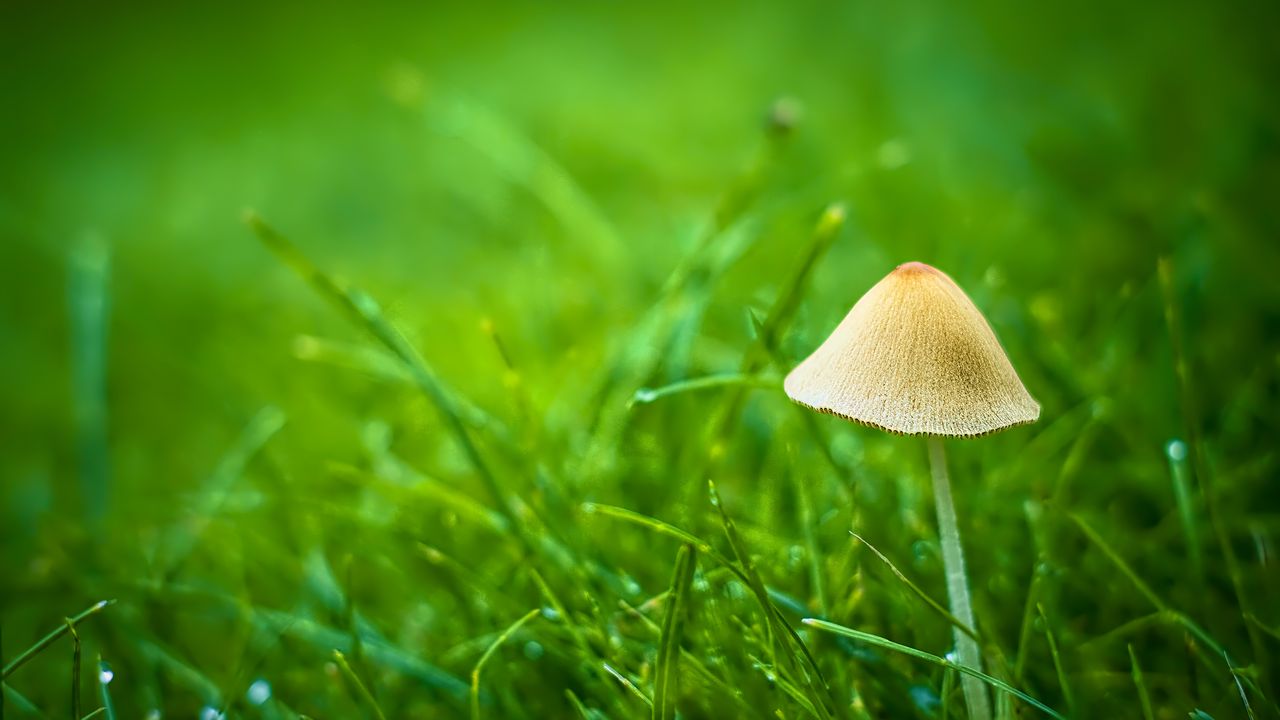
<box><xmin>929</xmin><ymin>437</ymin><xmax>991</xmax><ymax>720</ymax></box>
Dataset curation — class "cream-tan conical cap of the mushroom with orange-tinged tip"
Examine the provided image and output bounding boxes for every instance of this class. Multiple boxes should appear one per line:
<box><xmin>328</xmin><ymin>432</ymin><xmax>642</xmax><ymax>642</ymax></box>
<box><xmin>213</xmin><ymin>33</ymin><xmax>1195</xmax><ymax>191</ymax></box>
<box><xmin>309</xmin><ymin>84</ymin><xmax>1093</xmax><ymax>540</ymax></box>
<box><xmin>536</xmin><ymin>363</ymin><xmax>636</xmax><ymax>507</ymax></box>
<box><xmin>783</xmin><ymin>263</ymin><xmax>1039</xmax><ymax>437</ymax></box>
